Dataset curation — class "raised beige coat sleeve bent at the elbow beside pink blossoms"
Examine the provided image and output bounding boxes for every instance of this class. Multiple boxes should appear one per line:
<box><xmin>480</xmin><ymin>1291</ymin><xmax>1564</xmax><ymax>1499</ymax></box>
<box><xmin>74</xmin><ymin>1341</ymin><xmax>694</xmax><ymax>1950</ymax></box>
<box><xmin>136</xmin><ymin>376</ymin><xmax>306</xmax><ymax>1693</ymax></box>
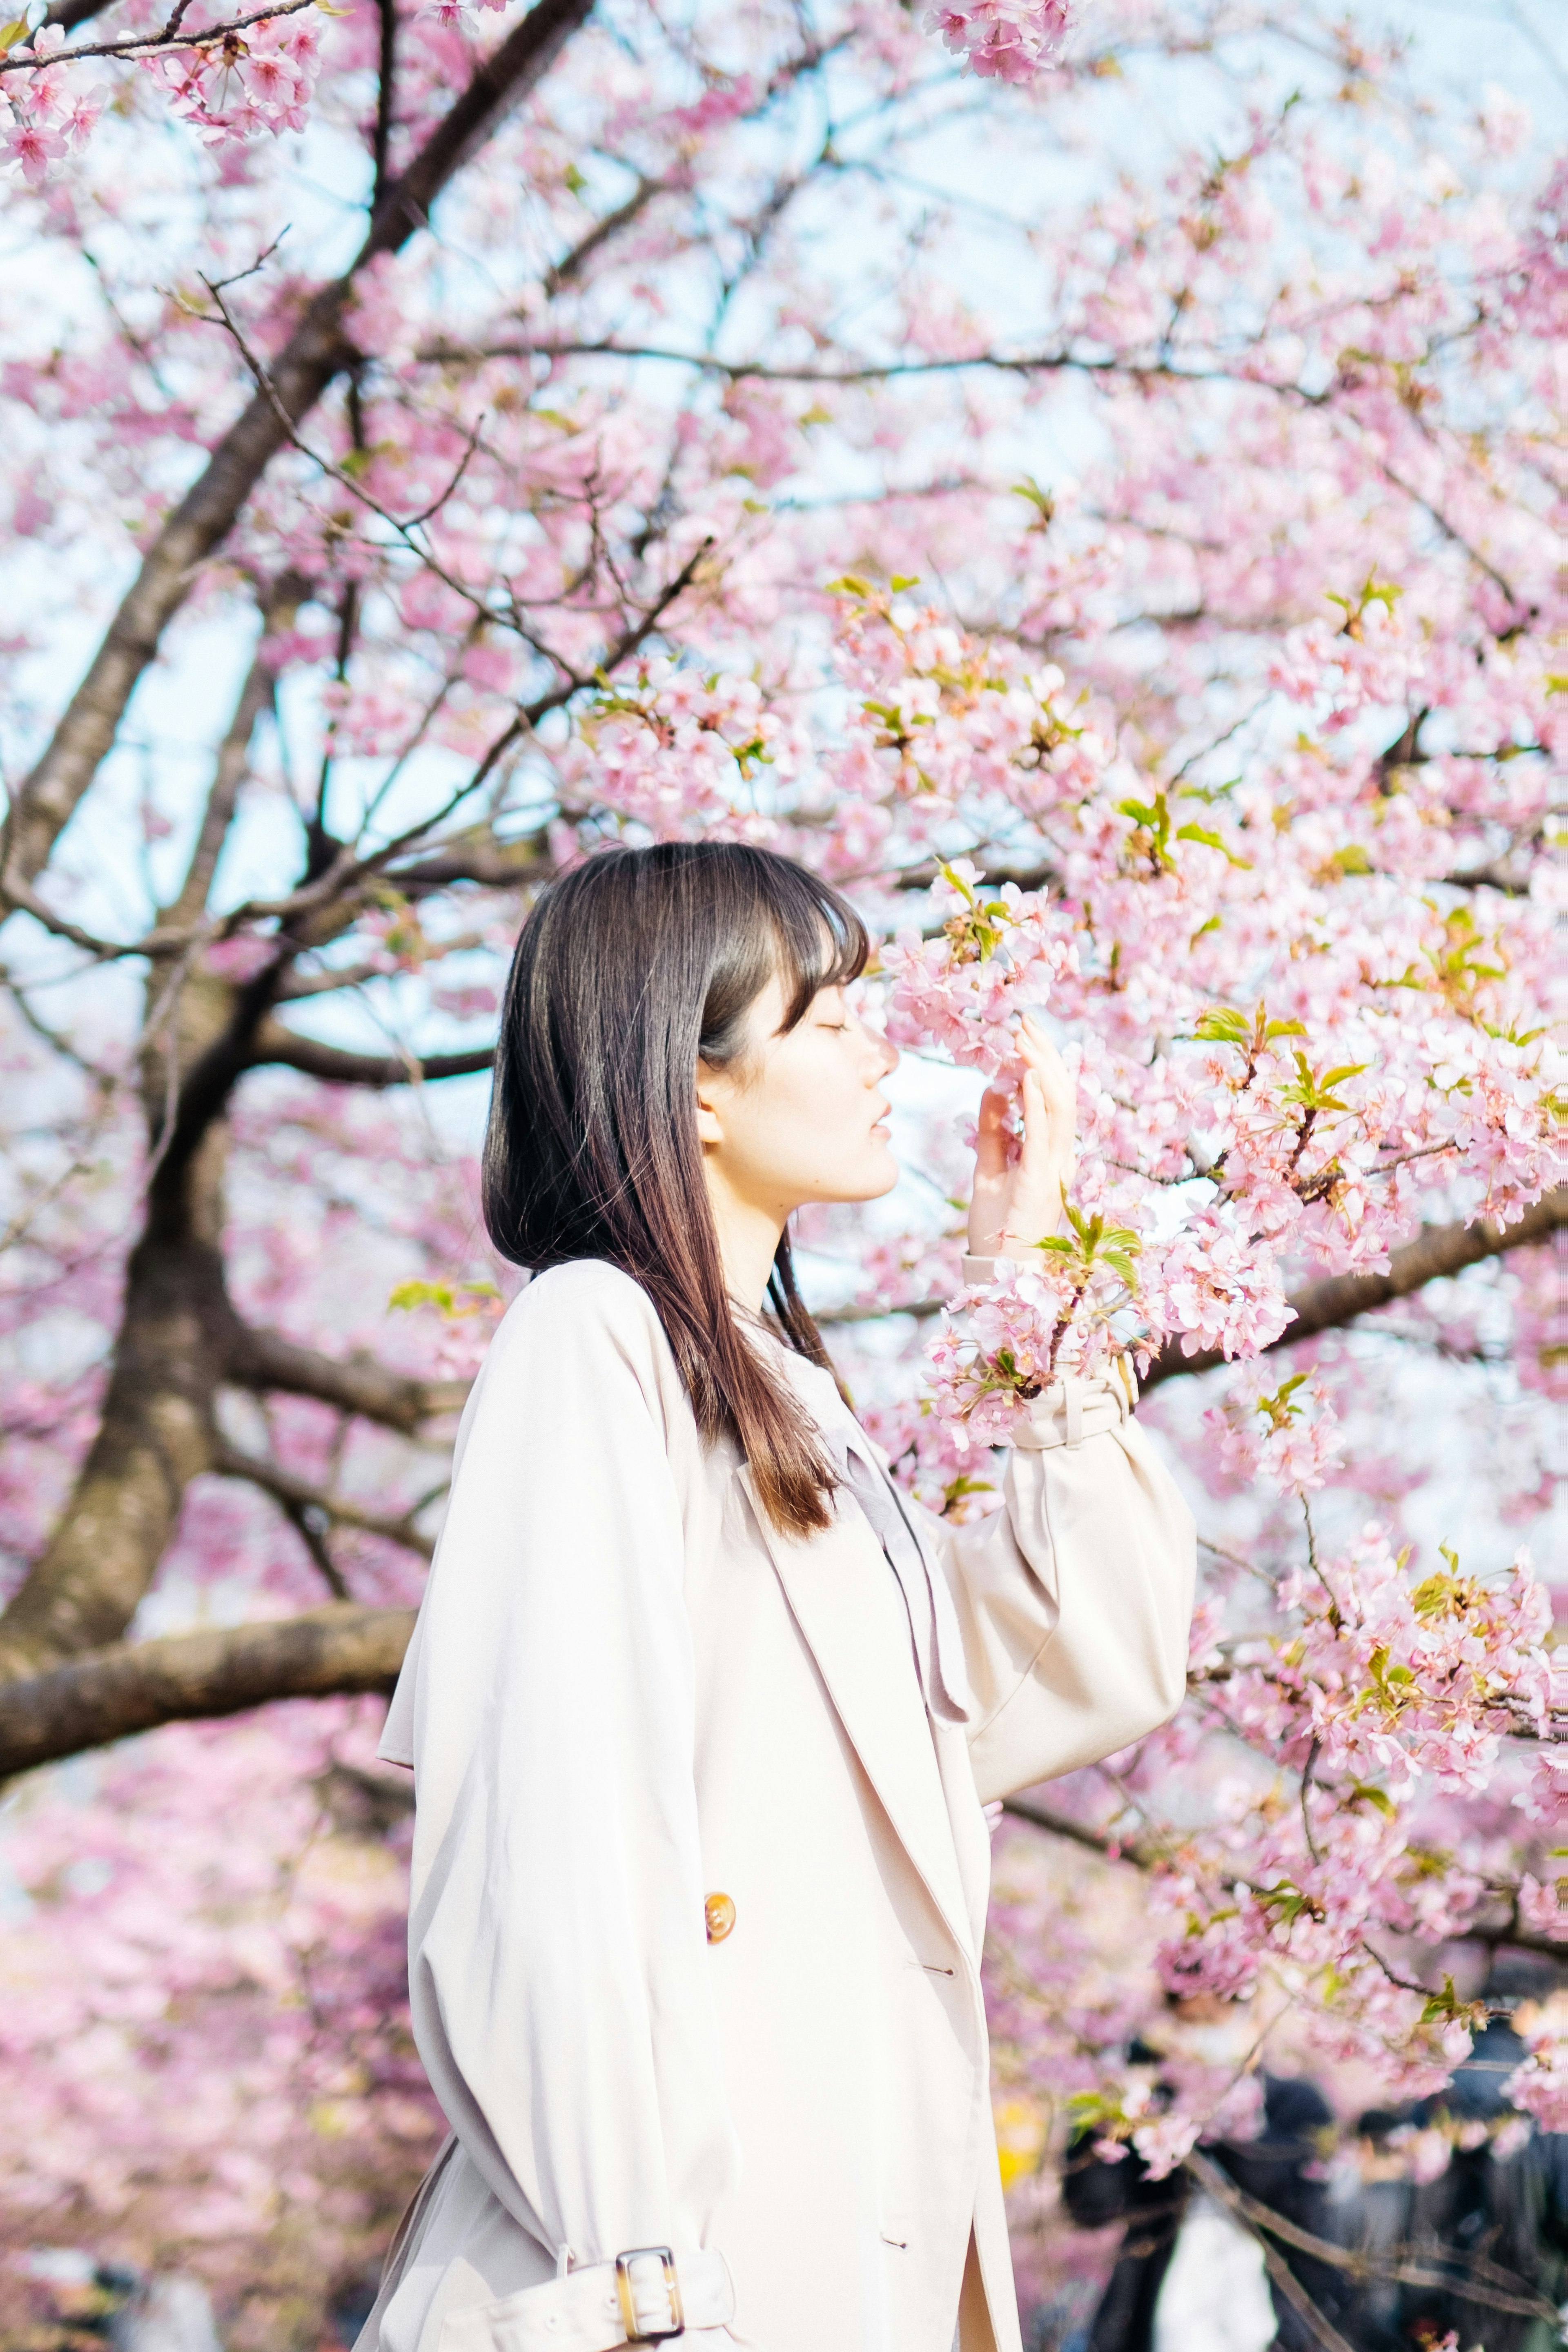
<box><xmin>938</xmin><ymin>1345</ymin><xmax>1196</xmax><ymax>1799</ymax></box>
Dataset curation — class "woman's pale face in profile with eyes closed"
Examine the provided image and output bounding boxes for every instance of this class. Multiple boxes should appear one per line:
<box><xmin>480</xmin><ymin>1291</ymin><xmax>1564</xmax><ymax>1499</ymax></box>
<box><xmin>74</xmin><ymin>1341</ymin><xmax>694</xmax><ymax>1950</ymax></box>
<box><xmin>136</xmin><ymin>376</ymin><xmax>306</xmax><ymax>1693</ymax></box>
<box><xmin>696</xmin><ymin>978</ymin><xmax>898</xmax><ymax>1223</ymax></box>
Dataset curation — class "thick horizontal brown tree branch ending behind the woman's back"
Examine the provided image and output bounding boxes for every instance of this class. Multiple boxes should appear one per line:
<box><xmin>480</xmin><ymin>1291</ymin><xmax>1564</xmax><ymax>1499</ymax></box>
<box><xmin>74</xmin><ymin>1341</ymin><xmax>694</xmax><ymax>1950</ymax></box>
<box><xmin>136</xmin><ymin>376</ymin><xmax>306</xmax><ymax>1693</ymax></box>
<box><xmin>0</xmin><ymin>1602</ymin><xmax>414</xmax><ymax>1776</ymax></box>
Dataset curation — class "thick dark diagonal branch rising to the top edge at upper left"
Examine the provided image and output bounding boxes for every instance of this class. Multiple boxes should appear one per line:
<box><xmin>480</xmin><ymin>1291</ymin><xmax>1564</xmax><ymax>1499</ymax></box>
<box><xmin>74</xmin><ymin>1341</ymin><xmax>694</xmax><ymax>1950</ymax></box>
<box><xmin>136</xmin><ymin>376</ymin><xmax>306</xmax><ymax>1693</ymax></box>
<box><xmin>0</xmin><ymin>0</ymin><xmax>592</xmax><ymax>898</ymax></box>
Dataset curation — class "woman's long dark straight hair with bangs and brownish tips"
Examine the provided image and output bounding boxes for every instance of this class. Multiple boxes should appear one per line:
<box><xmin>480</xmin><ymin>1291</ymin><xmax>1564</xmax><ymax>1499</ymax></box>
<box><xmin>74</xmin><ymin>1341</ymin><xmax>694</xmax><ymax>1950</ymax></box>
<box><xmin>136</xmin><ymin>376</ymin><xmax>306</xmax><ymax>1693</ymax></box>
<box><xmin>484</xmin><ymin>842</ymin><xmax>867</xmax><ymax>1534</ymax></box>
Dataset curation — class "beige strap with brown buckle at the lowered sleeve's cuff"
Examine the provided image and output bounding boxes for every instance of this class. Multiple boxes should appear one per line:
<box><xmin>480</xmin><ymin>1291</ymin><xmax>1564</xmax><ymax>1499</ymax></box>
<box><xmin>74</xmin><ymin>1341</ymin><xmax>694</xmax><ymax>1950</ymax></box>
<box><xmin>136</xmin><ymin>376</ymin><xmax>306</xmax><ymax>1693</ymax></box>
<box><xmin>437</xmin><ymin>2246</ymin><xmax>736</xmax><ymax>2352</ymax></box>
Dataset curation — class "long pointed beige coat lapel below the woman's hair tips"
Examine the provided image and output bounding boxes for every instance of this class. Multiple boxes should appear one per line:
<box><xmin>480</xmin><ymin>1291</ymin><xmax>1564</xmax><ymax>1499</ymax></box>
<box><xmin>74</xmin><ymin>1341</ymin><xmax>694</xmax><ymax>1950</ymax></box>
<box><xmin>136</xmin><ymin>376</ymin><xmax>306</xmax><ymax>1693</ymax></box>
<box><xmin>740</xmin><ymin>1468</ymin><xmax>973</xmax><ymax>1959</ymax></box>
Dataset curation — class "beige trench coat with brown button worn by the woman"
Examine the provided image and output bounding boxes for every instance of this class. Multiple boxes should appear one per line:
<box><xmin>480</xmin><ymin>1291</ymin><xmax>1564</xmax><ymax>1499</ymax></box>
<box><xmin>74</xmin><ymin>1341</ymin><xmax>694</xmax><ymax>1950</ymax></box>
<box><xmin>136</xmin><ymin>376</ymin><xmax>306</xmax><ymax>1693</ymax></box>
<box><xmin>360</xmin><ymin>1261</ymin><xmax>1194</xmax><ymax>2352</ymax></box>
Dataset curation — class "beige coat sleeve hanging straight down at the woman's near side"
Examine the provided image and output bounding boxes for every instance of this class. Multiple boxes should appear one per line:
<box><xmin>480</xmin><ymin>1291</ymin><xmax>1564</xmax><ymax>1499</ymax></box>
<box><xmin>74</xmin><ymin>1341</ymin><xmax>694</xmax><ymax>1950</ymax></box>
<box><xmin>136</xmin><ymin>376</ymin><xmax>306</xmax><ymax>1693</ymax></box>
<box><xmin>383</xmin><ymin>1263</ymin><xmax>736</xmax><ymax>2263</ymax></box>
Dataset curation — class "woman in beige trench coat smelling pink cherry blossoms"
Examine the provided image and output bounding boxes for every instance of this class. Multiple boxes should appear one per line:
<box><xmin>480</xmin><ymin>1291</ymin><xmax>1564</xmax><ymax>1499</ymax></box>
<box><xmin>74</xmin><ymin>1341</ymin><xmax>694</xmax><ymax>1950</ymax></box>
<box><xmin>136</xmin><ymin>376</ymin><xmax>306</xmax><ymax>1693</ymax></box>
<box><xmin>360</xmin><ymin>844</ymin><xmax>1192</xmax><ymax>2352</ymax></box>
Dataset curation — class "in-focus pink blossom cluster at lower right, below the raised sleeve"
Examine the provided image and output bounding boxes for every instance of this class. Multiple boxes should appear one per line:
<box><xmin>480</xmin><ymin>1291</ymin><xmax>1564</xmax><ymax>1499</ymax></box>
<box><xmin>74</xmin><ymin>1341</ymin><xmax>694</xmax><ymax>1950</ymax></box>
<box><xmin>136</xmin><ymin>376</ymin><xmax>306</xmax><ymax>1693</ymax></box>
<box><xmin>1100</xmin><ymin>1524</ymin><xmax>1568</xmax><ymax>2129</ymax></box>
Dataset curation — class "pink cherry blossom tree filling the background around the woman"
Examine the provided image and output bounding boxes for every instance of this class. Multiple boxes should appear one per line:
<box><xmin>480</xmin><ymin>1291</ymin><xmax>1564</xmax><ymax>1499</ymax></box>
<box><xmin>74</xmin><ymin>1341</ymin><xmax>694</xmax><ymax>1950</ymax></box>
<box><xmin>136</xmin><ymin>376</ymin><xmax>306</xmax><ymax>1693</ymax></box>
<box><xmin>0</xmin><ymin>0</ymin><xmax>1568</xmax><ymax>2340</ymax></box>
